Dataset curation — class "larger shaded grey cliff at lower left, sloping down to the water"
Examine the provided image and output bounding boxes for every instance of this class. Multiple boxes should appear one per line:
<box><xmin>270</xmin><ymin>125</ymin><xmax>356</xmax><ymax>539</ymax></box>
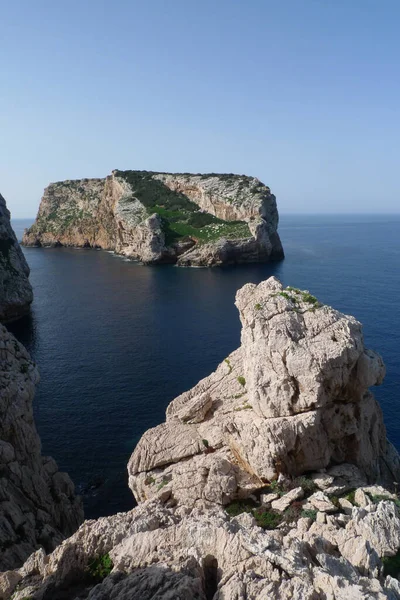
<box><xmin>0</xmin><ymin>325</ymin><xmax>83</xmax><ymax>570</ymax></box>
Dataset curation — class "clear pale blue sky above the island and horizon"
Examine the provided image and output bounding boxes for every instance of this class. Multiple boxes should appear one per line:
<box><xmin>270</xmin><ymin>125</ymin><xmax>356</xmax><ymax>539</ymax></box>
<box><xmin>0</xmin><ymin>0</ymin><xmax>400</xmax><ymax>217</ymax></box>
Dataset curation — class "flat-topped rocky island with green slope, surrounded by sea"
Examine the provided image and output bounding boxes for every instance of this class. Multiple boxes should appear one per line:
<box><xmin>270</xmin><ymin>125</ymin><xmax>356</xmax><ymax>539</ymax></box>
<box><xmin>23</xmin><ymin>171</ymin><xmax>283</xmax><ymax>266</ymax></box>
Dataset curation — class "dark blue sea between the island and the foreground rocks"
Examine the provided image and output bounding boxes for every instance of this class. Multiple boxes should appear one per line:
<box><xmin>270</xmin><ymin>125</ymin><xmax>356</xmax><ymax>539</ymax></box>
<box><xmin>8</xmin><ymin>215</ymin><xmax>400</xmax><ymax>517</ymax></box>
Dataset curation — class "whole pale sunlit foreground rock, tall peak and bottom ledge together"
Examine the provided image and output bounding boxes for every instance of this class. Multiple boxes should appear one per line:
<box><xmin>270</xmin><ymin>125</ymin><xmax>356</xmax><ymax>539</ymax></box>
<box><xmin>0</xmin><ymin>278</ymin><xmax>400</xmax><ymax>600</ymax></box>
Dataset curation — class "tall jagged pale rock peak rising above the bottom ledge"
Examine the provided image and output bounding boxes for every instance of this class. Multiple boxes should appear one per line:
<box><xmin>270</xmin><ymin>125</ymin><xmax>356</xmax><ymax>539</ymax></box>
<box><xmin>128</xmin><ymin>277</ymin><xmax>400</xmax><ymax>506</ymax></box>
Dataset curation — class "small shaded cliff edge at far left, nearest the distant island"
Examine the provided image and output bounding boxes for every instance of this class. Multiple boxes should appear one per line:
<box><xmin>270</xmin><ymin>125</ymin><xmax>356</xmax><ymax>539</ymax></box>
<box><xmin>0</xmin><ymin>194</ymin><xmax>33</xmax><ymax>323</ymax></box>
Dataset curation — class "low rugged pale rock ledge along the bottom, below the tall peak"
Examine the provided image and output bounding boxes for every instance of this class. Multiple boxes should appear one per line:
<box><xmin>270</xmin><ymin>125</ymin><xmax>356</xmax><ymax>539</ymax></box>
<box><xmin>0</xmin><ymin>472</ymin><xmax>400</xmax><ymax>600</ymax></box>
